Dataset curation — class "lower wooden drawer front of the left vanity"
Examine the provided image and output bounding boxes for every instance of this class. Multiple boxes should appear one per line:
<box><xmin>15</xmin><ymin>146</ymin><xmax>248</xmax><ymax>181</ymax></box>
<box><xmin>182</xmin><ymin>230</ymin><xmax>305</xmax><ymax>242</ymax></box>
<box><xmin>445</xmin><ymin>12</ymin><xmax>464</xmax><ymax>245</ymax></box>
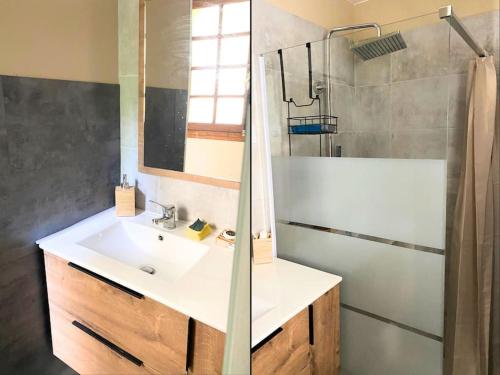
<box><xmin>50</xmin><ymin>305</ymin><xmax>160</xmax><ymax>375</ymax></box>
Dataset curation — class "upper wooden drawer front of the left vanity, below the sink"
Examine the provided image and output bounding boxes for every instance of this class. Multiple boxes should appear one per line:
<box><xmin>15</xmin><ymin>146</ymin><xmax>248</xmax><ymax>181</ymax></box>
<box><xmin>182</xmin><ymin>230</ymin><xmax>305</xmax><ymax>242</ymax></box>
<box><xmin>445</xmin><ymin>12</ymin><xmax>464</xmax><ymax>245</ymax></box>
<box><xmin>45</xmin><ymin>253</ymin><xmax>189</xmax><ymax>374</ymax></box>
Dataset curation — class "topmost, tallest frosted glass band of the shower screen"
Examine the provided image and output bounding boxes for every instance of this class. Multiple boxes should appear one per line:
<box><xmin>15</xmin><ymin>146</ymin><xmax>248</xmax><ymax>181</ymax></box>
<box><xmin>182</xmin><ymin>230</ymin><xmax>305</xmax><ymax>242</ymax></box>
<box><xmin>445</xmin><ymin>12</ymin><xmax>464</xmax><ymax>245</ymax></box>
<box><xmin>272</xmin><ymin>157</ymin><xmax>446</xmax><ymax>249</ymax></box>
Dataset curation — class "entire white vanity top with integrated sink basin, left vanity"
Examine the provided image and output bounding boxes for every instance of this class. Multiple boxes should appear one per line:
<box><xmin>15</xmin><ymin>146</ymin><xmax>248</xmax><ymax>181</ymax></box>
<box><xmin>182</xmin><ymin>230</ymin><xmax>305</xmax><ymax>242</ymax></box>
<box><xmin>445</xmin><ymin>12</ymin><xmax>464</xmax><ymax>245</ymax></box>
<box><xmin>37</xmin><ymin>207</ymin><xmax>234</xmax><ymax>334</ymax></box>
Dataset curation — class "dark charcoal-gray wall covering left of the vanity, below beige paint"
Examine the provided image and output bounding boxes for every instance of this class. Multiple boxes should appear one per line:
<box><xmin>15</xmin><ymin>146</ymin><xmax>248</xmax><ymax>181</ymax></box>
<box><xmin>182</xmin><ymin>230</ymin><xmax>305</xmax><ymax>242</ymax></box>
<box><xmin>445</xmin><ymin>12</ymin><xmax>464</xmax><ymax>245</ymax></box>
<box><xmin>0</xmin><ymin>76</ymin><xmax>120</xmax><ymax>375</ymax></box>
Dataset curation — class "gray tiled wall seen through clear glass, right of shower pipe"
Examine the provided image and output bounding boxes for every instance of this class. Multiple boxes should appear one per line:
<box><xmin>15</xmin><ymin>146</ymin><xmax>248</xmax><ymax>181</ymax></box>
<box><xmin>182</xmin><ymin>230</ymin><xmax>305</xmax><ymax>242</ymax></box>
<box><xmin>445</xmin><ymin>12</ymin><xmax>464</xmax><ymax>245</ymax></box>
<box><xmin>333</xmin><ymin>24</ymin><xmax>449</xmax><ymax>159</ymax></box>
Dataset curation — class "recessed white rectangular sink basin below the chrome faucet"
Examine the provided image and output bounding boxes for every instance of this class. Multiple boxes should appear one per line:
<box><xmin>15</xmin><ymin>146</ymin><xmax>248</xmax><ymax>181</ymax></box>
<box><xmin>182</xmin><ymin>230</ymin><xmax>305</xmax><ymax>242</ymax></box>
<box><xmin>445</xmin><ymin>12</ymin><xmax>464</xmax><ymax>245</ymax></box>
<box><xmin>78</xmin><ymin>220</ymin><xmax>209</xmax><ymax>282</ymax></box>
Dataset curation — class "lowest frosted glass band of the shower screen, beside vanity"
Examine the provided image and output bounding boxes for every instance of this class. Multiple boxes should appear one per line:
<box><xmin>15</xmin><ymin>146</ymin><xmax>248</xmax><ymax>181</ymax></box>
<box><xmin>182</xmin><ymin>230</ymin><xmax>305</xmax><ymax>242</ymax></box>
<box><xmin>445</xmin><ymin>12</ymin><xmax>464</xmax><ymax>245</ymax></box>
<box><xmin>340</xmin><ymin>308</ymin><xmax>443</xmax><ymax>375</ymax></box>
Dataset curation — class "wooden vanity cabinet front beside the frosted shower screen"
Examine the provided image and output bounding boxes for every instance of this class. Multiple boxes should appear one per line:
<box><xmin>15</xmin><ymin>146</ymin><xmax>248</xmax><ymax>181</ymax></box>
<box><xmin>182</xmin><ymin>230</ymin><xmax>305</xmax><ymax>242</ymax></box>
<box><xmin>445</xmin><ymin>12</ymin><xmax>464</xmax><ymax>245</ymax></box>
<box><xmin>252</xmin><ymin>286</ymin><xmax>340</xmax><ymax>375</ymax></box>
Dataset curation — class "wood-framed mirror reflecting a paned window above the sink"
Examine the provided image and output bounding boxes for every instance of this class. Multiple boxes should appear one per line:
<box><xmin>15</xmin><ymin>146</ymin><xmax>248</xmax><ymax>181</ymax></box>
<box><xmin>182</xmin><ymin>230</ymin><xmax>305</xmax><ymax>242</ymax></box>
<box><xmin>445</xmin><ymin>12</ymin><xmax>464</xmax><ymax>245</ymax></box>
<box><xmin>139</xmin><ymin>0</ymin><xmax>250</xmax><ymax>188</ymax></box>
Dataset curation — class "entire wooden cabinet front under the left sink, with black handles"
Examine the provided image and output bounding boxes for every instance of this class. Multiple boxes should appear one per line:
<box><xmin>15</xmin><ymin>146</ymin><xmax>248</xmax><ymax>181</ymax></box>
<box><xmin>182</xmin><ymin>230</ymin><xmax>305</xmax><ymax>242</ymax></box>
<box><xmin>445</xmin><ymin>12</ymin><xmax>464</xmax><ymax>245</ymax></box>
<box><xmin>45</xmin><ymin>253</ymin><xmax>225</xmax><ymax>375</ymax></box>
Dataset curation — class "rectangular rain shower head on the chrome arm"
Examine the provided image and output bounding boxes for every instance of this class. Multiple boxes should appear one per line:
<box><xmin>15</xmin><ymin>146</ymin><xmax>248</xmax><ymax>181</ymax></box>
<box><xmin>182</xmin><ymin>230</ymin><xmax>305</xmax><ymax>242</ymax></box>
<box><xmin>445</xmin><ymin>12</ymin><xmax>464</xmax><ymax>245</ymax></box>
<box><xmin>351</xmin><ymin>31</ymin><xmax>406</xmax><ymax>60</ymax></box>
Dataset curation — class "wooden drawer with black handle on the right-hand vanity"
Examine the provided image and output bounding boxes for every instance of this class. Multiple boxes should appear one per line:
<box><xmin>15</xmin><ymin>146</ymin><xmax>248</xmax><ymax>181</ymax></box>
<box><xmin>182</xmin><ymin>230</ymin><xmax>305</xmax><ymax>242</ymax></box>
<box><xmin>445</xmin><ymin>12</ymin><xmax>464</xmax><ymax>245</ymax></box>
<box><xmin>252</xmin><ymin>309</ymin><xmax>311</xmax><ymax>375</ymax></box>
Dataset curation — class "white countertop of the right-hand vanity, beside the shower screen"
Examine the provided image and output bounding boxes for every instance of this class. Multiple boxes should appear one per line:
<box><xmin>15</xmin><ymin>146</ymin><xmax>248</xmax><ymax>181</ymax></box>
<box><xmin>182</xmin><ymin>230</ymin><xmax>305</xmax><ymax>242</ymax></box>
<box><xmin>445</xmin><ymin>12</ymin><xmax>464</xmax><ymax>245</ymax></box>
<box><xmin>252</xmin><ymin>258</ymin><xmax>342</xmax><ymax>347</ymax></box>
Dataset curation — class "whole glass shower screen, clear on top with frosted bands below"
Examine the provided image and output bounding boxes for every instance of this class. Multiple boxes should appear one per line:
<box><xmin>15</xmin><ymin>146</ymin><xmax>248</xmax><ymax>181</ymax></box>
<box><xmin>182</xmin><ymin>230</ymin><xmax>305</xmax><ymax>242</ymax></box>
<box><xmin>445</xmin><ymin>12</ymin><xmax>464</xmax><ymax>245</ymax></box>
<box><xmin>261</xmin><ymin>15</ymin><xmax>454</xmax><ymax>375</ymax></box>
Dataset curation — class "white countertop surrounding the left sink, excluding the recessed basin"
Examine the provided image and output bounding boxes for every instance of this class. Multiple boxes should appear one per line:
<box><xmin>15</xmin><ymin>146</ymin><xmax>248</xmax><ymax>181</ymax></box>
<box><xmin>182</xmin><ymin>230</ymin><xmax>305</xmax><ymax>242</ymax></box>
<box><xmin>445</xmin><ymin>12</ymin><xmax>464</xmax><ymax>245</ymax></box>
<box><xmin>37</xmin><ymin>208</ymin><xmax>233</xmax><ymax>333</ymax></box>
